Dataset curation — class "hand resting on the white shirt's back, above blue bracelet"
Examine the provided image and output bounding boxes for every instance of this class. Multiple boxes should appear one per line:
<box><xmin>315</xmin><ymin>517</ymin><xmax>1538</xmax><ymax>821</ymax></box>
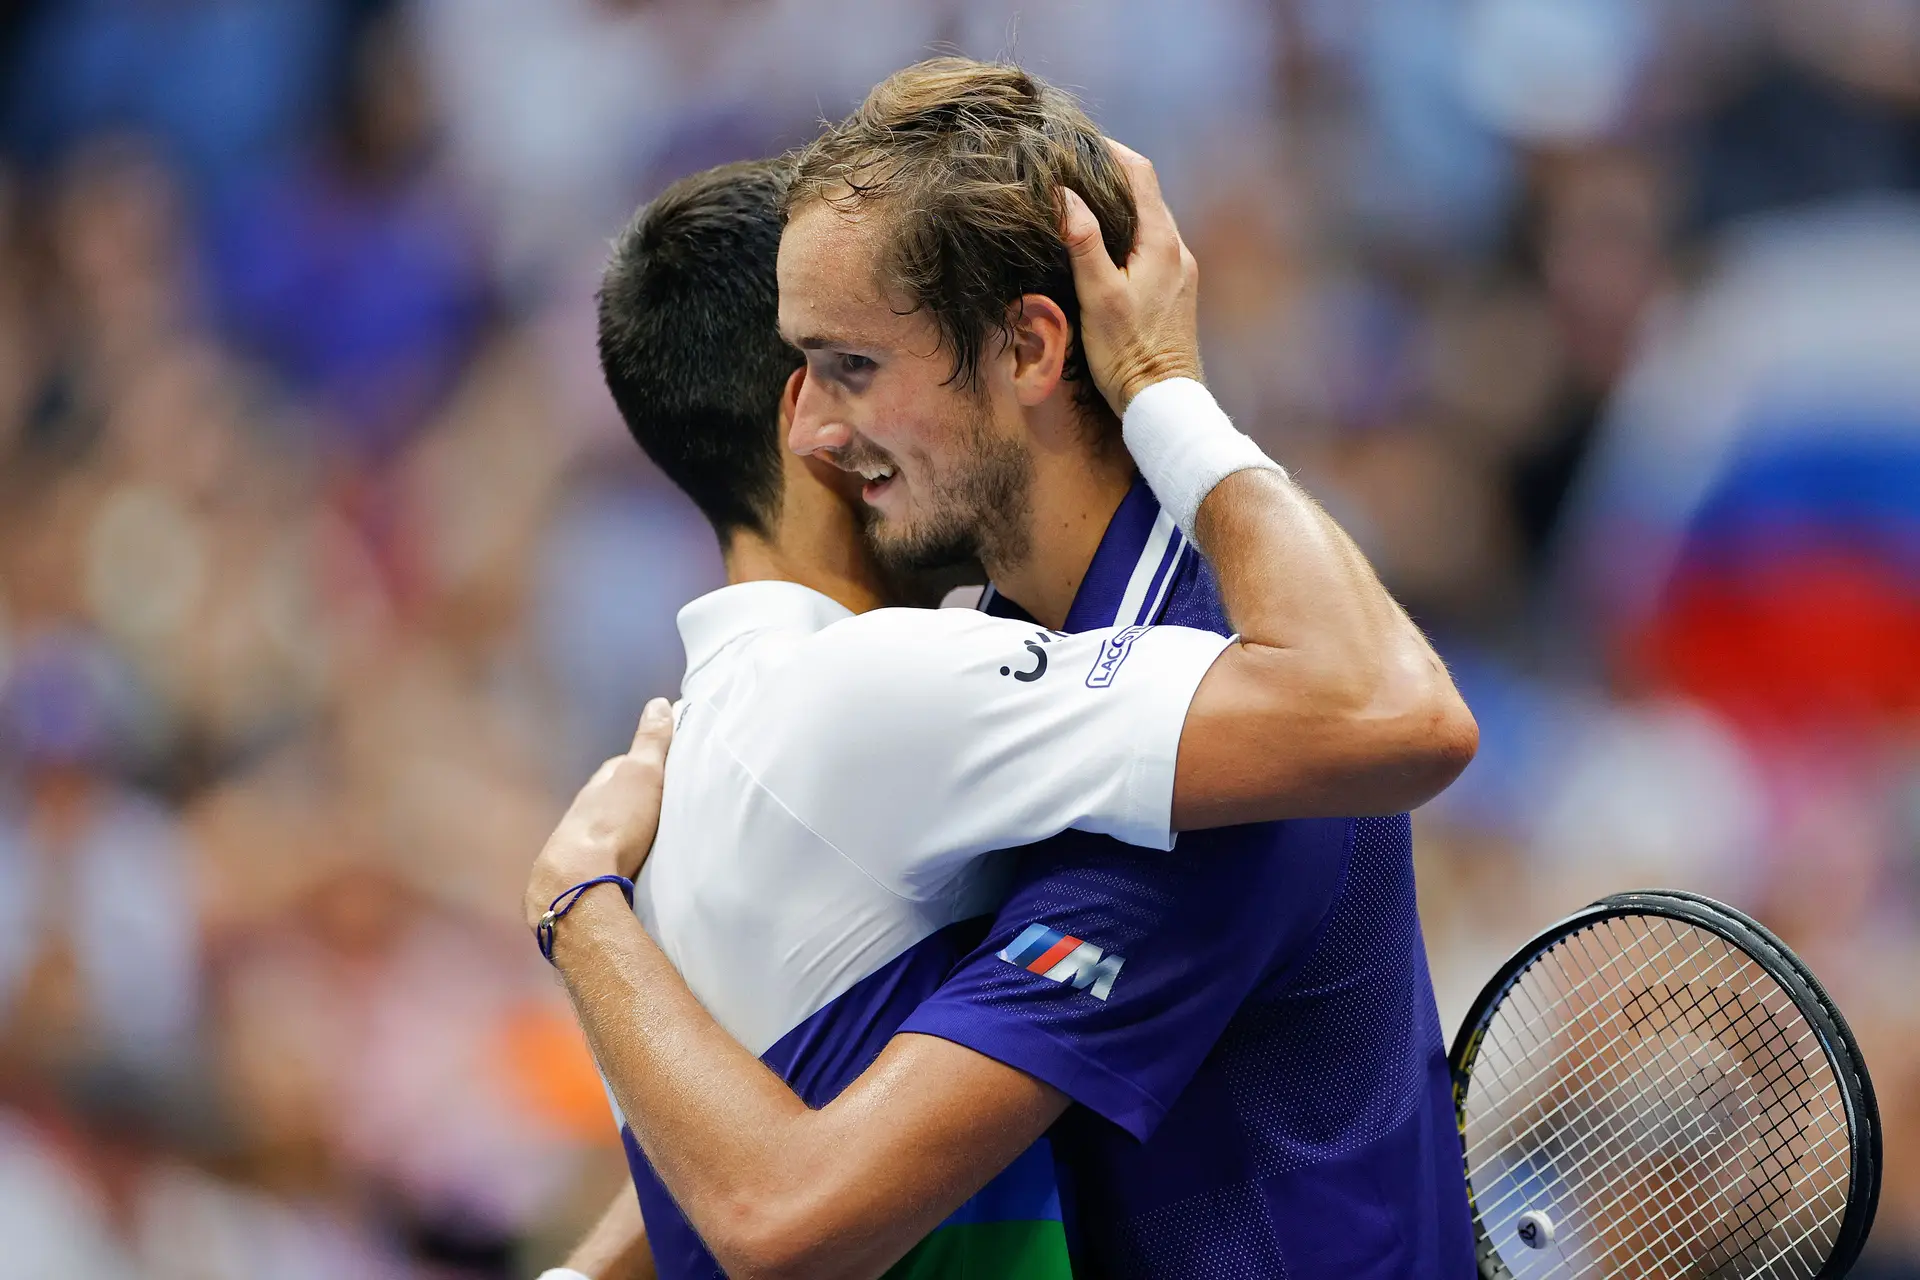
<box><xmin>524</xmin><ymin>699</ymin><xmax>674</xmax><ymax>927</ymax></box>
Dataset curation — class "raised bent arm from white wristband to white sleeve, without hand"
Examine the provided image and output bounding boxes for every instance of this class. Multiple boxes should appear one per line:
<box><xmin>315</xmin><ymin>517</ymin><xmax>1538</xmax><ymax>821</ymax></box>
<box><xmin>1127</xmin><ymin>384</ymin><xmax>1478</xmax><ymax>829</ymax></box>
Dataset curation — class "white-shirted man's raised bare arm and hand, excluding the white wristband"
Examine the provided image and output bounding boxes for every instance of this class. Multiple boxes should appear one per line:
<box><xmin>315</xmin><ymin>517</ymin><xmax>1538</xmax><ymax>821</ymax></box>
<box><xmin>1066</xmin><ymin>144</ymin><xmax>1478</xmax><ymax>829</ymax></box>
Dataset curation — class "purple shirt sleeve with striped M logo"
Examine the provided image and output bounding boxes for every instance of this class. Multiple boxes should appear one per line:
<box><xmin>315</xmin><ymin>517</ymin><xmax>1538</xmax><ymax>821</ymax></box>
<box><xmin>900</xmin><ymin>818</ymin><xmax>1354</xmax><ymax>1142</ymax></box>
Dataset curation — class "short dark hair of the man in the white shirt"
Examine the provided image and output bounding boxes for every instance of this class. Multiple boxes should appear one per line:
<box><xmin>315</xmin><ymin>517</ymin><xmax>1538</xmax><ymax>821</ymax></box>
<box><xmin>599</xmin><ymin>161</ymin><xmax>801</xmax><ymax>541</ymax></box>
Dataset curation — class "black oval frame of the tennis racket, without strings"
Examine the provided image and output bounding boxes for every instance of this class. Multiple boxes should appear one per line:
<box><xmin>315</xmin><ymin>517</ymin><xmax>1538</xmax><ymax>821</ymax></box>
<box><xmin>1448</xmin><ymin>889</ymin><xmax>1880</xmax><ymax>1280</ymax></box>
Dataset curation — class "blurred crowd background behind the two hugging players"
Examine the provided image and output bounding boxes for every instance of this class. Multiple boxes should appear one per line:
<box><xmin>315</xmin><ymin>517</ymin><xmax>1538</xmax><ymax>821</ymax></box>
<box><xmin>0</xmin><ymin>0</ymin><xmax>1920</xmax><ymax>1280</ymax></box>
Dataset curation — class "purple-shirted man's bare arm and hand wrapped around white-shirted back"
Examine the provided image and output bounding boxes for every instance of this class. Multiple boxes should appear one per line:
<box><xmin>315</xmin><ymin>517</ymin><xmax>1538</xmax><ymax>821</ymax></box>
<box><xmin>526</xmin><ymin>702</ymin><xmax>1068</xmax><ymax>1278</ymax></box>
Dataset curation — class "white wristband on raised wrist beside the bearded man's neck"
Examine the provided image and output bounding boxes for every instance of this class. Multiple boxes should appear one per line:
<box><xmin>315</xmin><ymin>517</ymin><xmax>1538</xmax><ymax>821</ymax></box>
<box><xmin>1119</xmin><ymin>378</ymin><xmax>1286</xmax><ymax>539</ymax></box>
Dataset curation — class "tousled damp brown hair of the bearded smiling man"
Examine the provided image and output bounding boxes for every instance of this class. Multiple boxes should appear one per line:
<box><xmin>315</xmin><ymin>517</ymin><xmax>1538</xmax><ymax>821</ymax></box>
<box><xmin>787</xmin><ymin>58</ymin><xmax>1137</xmax><ymax>413</ymax></box>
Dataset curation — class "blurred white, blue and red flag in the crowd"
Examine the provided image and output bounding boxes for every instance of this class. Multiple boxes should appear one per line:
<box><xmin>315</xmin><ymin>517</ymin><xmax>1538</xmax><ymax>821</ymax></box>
<box><xmin>1563</xmin><ymin>200</ymin><xmax>1920</xmax><ymax>735</ymax></box>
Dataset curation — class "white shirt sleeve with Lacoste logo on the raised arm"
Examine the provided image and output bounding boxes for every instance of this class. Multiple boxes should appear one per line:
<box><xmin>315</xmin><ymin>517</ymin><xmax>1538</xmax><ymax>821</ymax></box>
<box><xmin>728</xmin><ymin>608</ymin><xmax>1229</xmax><ymax>898</ymax></box>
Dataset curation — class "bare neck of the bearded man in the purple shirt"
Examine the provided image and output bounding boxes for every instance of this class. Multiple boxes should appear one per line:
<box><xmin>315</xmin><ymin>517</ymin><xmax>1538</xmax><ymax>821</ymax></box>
<box><xmin>987</xmin><ymin>432</ymin><xmax>1133</xmax><ymax>629</ymax></box>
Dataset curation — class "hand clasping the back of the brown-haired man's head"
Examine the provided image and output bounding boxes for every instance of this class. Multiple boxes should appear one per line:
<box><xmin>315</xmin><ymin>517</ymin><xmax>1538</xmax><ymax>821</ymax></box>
<box><xmin>1060</xmin><ymin>138</ymin><xmax>1200</xmax><ymax>415</ymax></box>
